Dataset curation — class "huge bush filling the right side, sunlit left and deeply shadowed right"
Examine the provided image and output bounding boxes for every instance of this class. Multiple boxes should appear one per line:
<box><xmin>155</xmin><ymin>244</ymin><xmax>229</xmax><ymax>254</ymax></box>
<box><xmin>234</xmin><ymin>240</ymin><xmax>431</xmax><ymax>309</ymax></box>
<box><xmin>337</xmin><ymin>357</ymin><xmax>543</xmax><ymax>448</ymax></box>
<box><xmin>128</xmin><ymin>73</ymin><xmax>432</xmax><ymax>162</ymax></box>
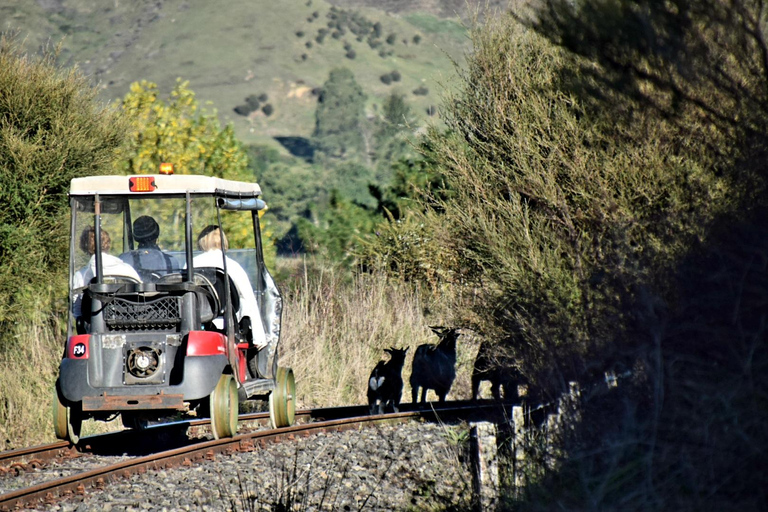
<box><xmin>408</xmin><ymin>1</ymin><xmax>768</xmax><ymax>510</ymax></box>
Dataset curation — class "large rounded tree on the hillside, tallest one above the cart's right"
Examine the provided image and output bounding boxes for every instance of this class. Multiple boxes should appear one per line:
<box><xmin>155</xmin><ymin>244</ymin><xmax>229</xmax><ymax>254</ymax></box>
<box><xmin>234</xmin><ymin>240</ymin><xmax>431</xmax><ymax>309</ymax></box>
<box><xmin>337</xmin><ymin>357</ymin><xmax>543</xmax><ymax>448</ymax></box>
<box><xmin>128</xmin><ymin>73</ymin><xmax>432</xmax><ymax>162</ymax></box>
<box><xmin>312</xmin><ymin>68</ymin><xmax>366</xmax><ymax>157</ymax></box>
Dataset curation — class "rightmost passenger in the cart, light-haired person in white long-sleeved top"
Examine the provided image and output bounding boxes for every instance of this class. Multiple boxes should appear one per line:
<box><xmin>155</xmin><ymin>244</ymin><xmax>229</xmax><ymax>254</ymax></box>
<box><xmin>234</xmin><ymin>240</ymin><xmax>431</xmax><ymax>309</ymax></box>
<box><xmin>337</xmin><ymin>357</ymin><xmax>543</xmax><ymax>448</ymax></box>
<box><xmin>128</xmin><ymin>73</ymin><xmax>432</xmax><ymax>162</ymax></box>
<box><xmin>192</xmin><ymin>225</ymin><xmax>267</xmax><ymax>349</ymax></box>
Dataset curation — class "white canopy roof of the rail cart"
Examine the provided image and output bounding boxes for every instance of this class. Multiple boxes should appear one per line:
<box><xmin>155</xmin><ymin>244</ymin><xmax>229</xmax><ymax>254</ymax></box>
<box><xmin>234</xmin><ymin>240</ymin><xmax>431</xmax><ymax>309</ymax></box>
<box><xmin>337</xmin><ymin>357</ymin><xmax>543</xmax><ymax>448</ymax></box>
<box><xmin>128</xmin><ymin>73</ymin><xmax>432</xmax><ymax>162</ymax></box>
<box><xmin>69</xmin><ymin>174</ymin><xmax>261</xmax><ymax>198</ymax></box>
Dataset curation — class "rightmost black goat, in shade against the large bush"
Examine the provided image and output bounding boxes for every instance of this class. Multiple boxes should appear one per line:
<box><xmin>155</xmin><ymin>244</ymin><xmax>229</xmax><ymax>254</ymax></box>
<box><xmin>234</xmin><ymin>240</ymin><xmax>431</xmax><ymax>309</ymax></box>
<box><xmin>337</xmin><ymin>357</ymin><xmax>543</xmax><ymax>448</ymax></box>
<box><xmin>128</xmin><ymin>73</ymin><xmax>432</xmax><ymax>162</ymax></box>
<box><xmin>472</xmin><ymin>341</ymin><xmax>525</xmax><ymax>400</ymax></box>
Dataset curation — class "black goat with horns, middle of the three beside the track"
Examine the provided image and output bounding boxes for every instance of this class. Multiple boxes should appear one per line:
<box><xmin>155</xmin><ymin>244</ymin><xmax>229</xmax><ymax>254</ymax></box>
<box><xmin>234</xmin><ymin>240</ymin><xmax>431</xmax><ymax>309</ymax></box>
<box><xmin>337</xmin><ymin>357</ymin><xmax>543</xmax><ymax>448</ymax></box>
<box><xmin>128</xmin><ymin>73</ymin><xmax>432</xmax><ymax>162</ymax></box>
<box><xmin>410</xmin><ymin>327</ymin><xmax>459</xmax><ymax>403</ymax></box>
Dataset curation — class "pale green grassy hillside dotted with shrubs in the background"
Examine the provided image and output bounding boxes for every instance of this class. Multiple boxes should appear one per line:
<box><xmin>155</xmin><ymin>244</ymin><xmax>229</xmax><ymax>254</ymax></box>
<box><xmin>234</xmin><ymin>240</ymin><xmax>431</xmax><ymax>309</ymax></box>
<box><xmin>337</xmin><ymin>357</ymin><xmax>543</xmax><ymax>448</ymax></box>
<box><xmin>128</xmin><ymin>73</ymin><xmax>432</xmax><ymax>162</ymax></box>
<box><xmin>0</xmin><ymin>0</ymin><xmax>468</xmax><ymax>143</ymax></box>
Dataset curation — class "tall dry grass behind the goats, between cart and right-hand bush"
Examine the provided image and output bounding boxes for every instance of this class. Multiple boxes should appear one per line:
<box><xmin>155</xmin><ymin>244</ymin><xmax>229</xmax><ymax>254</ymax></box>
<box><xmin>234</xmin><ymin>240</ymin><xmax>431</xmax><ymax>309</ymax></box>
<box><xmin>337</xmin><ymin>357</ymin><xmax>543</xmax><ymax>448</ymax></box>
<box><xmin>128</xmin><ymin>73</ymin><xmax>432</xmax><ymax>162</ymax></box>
<box><xmin>281</xmin><ymin>263</ymin><xmax>477</xmax><ymax>407</ymax></box>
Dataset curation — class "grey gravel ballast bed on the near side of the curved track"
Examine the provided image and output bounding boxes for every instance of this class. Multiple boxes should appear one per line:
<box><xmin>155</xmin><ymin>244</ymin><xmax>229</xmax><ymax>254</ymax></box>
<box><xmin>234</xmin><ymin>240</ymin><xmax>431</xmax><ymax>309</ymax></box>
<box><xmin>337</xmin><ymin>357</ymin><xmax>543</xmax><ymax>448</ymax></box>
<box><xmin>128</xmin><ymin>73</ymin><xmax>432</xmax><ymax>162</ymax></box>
<box><xmin>34</xmin><ymin>422</ymin><xmax>471</xmax><ymax>512</ymax></box>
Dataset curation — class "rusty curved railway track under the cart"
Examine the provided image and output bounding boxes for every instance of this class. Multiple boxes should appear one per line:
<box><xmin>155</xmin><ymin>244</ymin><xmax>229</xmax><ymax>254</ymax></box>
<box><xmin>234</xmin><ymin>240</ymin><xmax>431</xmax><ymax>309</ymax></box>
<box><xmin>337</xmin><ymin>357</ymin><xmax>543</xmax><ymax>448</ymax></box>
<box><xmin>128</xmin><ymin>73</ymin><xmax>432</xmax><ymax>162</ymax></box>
<box><xmin>0</xmin><ymin>402</ymin><xmax>508</xmax><ymax>511</ymax></box>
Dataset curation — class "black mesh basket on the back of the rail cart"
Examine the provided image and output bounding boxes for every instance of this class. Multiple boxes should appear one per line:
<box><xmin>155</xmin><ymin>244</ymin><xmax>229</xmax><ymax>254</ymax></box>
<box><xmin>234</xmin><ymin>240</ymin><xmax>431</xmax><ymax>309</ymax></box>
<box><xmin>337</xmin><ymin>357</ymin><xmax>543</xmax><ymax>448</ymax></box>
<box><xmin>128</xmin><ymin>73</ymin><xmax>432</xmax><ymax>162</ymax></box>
<box><xmin>104</xmin><ymin>297</ymin><xmax>181</xmax><ymax>330</ymax></box>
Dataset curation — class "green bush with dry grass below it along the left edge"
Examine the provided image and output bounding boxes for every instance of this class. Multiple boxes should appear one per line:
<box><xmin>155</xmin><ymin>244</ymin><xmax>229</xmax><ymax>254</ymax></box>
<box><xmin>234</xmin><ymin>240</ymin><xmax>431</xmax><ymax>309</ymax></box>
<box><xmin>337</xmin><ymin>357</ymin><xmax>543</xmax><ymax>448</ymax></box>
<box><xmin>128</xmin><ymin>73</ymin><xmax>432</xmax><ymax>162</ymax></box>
<box><xmin>0</xmin><ymin>37</ymin><xmax>124</xmax><ymax>449</ymax></box>
